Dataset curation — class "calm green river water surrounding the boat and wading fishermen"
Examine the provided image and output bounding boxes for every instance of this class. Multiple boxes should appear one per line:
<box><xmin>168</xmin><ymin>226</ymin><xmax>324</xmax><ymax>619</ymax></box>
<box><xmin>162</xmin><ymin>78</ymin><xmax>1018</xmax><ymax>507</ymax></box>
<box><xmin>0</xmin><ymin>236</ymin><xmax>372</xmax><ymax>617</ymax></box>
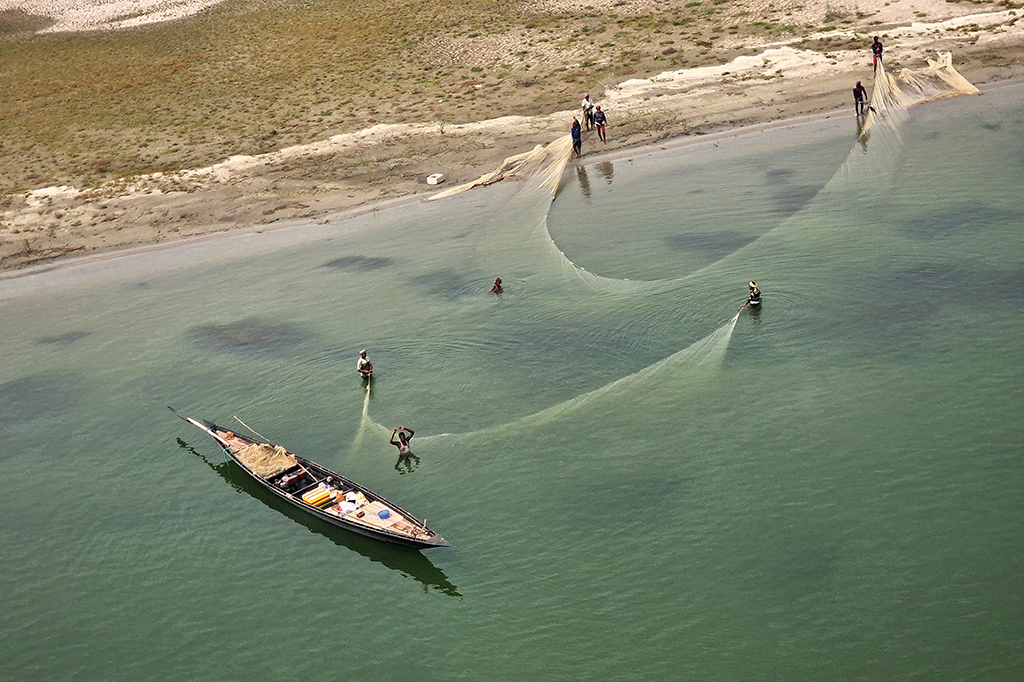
<box><xmin>0</xmin><ymin>86</ymin><xmax>1024</xmax><ymax>680</ymax></box>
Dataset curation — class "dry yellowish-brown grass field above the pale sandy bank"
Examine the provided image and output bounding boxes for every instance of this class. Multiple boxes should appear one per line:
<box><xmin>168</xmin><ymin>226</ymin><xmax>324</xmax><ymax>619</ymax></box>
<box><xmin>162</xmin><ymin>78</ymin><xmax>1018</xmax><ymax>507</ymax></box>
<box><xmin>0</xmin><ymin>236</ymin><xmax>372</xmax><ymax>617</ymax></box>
<box><xmin>0</xmin><ymin>0</ymin><xmax>929</xmax><ymax>191</ymax></box>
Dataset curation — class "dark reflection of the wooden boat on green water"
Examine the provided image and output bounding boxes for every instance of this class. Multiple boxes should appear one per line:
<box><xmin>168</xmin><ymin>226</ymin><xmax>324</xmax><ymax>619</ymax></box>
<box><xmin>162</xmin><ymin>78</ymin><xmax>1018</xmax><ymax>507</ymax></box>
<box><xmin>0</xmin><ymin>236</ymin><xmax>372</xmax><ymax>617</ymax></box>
<box><xmin>177</xmin><ymin>438</ymin><xmax>462</xmax><ymax>597</ymax></box>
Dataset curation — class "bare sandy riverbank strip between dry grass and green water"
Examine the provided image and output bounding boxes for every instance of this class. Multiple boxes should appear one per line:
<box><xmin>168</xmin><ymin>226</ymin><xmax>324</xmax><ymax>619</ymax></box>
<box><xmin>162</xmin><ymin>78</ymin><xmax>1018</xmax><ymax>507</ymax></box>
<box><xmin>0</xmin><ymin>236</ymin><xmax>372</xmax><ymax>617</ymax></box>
<box><xmin>0</xmin><ymin>1</ymin><xmax>1024</xmax><ymax>272</ymax></box>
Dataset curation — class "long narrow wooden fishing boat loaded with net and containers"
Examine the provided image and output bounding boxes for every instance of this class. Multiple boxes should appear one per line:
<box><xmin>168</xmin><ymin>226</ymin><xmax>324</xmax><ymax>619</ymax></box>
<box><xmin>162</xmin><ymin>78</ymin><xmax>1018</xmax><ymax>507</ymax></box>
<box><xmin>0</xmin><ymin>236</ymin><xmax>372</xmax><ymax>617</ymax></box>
<box><xmin>169</xmin><ymin>408</ymin><xmax>452</xmax><ymax>549</ymax></box>
